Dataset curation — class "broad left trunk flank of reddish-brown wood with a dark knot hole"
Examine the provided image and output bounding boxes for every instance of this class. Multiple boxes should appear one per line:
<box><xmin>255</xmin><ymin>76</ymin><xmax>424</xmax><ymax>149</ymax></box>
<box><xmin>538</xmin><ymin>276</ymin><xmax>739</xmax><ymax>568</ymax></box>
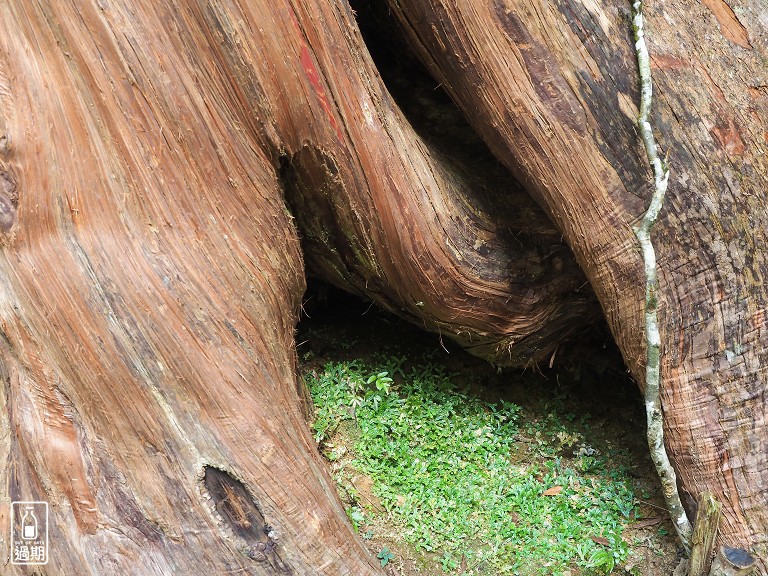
<box><xmin>0</xmin><ymin>0</ymin><xmax>379</xmax><ymax>576</ymax></box>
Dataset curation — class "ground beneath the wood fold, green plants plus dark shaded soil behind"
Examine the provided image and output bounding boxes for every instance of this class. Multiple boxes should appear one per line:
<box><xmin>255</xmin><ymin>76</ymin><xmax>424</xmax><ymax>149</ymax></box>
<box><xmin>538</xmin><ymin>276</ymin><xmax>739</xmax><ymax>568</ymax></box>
<box><xmin>297</xmin><ymin>284</ymin><xmax>679</xmax><ymax>576</ymax></box>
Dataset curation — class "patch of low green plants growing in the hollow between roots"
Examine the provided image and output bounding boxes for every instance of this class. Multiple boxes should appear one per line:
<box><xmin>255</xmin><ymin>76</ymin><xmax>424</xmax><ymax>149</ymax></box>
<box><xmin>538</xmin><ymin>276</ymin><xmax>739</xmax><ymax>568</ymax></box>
<box><xmin>304</xmin><ymin>356</ymin><xmax>638</xmax><ymax>576</ymax></box>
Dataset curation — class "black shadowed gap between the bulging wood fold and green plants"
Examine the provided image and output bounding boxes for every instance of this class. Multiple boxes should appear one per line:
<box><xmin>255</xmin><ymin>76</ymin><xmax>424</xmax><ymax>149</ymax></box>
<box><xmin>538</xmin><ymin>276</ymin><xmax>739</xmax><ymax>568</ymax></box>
<box><xmin>296</xmin><ymin>275</ymin><xmax>636</xmax><ymax>404</ymax></box>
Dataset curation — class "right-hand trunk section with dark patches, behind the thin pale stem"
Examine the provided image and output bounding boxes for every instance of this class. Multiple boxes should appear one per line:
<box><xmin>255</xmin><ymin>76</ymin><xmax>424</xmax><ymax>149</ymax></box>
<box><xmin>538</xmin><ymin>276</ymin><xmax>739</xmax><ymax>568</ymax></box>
<box><xmin>388</xmin><ymin>0</ymin><xmax>768</xmax><ymax>573</ymax></box>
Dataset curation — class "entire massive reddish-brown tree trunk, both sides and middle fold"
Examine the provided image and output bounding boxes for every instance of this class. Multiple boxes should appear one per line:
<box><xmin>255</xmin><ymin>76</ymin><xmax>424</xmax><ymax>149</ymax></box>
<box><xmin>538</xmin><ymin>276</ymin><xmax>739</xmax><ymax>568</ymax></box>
<box><xmin>0</xmin><ymin>0</ymin><xmax>768</xmax><ymax>575</ymax></box>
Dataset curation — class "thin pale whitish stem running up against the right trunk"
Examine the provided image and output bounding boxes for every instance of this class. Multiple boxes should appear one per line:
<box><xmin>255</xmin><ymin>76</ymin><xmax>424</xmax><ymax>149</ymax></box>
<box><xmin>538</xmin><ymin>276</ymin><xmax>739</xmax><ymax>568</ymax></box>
<box><xmin>632</xmin><ymin>0</ymin><xmax>692</xmax><ymax>552</ymax></box>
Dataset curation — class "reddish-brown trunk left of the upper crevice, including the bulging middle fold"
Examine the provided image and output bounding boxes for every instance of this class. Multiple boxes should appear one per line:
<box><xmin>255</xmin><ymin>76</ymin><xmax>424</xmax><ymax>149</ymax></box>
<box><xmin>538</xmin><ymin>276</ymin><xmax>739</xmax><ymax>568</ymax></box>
<box><xmin>0</xmin><ymin>2</ymin><xmax>597</xmax><ymax>575</ymax></box>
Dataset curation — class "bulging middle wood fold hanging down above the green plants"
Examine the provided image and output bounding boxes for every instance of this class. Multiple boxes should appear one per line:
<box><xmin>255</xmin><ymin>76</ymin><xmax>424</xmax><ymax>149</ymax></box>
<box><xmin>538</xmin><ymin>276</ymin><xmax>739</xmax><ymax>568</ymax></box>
<box><xmin>267</xmin><ymin>3</ymin><xmax>599</xmax><ymax>366</ymax></box>
